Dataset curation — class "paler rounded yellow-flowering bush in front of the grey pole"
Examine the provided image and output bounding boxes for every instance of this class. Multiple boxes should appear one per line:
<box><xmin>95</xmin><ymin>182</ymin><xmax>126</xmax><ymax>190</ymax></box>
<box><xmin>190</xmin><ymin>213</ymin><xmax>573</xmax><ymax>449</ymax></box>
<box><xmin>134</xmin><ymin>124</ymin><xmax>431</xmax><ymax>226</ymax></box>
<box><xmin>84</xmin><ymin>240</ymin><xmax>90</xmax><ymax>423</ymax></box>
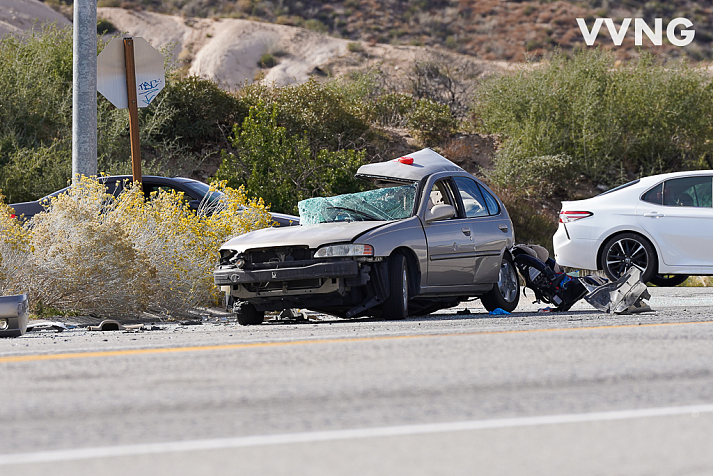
<box><xmin>24</xmin><ymin>178</ymin><xmax>156</xmax><ymax>316</ymax></box>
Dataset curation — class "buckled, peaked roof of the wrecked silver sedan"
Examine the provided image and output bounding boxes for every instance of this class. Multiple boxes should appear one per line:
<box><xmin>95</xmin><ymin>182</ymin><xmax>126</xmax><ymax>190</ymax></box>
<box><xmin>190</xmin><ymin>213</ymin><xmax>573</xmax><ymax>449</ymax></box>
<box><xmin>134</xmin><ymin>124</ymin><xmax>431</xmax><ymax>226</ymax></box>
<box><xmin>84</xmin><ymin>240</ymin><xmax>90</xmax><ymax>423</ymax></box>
<box><xmin>356</xmin><ymin>149</ymin><xmax>465</xmax><ymax>182</ymax></box>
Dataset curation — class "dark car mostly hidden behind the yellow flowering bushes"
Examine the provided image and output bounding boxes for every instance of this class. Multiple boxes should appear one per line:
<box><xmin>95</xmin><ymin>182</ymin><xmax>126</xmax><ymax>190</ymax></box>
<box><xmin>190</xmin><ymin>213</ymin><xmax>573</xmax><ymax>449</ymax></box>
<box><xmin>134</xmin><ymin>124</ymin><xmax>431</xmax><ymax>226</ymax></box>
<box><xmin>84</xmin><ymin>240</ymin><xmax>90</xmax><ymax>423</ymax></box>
<box><xmin>10</xmin><ymin>175</ymin><xmax>299</xmax><ymax>226</ymax></box>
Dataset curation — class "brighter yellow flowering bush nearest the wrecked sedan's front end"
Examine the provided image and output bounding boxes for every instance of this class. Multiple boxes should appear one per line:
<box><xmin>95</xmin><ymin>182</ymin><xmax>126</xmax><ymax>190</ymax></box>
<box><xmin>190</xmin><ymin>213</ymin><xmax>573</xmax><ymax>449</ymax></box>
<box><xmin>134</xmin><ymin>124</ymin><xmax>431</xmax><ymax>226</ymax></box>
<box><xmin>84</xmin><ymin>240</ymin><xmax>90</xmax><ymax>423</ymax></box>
<box><xmin>115</xmin><ymin>178</ymin><xmax>271</xmax><ymax>313</ymax></box>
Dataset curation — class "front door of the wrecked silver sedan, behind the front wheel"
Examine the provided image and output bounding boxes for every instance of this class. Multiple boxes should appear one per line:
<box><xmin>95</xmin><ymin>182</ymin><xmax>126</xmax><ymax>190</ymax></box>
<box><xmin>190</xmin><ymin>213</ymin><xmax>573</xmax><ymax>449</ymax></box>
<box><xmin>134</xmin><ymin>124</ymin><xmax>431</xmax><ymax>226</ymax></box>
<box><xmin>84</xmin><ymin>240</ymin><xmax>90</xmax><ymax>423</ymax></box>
<box><xmin>424</xmin><ymin>178</ymin><xmax>475</xmax><ymax>286</ymax></box>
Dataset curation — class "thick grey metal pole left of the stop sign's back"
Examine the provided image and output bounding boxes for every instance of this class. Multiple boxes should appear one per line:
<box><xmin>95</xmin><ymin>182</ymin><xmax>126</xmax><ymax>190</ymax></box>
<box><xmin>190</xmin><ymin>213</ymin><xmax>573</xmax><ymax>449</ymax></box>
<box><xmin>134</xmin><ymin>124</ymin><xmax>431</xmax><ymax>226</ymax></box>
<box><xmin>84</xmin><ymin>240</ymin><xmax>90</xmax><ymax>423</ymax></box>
<box><xmin>72</xmin><ymin>0</ymin><xmax>97</xmax><ymax>183</ymax></box>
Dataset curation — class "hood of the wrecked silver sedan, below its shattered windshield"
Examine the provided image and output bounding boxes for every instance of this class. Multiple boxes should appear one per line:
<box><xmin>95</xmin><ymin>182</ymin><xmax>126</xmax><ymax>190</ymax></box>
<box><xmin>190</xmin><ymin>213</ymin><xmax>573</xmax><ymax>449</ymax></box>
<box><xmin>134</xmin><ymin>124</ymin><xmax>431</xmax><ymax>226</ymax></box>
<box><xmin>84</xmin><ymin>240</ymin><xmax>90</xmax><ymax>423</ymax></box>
<box><xmin>220</xmin><ymin>221</ymin><xmax>391</xmax><ymax>252</ymax></box>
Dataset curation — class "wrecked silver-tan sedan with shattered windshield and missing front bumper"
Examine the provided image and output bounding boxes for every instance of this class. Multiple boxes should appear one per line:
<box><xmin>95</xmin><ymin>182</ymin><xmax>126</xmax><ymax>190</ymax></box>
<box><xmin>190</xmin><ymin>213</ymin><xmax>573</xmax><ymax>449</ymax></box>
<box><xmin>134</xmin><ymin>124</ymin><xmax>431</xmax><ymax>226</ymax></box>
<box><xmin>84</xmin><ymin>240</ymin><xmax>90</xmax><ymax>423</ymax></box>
<box><xmin>214</xmin><ymin>149</ymin><xmax>520</xmax><ymax>325</ymax></box>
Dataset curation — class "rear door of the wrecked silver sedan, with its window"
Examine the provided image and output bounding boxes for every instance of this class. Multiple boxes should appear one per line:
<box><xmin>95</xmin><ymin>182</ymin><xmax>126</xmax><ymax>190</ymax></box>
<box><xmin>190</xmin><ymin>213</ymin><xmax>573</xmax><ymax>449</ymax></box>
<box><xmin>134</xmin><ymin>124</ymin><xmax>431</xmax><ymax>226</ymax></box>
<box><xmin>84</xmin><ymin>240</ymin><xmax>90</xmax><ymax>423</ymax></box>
<box><xmin>454</xmin><ymin>177</ymin><xmax>510</xmax><ymax>284</ymax></box>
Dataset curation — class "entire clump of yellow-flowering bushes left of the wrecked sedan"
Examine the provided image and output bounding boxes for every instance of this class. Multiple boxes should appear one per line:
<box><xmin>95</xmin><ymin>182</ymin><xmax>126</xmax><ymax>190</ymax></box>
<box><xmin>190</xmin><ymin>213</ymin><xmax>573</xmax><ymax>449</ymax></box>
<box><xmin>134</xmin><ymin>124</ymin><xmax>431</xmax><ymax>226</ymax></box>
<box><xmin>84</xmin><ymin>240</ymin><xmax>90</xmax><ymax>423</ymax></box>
<box><xmin>0</xmin><ymin>177</ymin><xmax>271</xmax><ymax>316</ymax></box>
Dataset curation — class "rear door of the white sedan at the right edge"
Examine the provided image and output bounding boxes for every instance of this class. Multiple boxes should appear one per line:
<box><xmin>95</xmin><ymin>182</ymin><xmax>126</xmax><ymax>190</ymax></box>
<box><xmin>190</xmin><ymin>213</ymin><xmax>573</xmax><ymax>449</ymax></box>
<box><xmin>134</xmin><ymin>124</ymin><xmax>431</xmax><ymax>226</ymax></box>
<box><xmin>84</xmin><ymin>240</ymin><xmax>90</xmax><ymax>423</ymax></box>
<box><xmin>636</xmin><ymin>175</ymin><xmax>713</xmax><ymax>266</ymax></box>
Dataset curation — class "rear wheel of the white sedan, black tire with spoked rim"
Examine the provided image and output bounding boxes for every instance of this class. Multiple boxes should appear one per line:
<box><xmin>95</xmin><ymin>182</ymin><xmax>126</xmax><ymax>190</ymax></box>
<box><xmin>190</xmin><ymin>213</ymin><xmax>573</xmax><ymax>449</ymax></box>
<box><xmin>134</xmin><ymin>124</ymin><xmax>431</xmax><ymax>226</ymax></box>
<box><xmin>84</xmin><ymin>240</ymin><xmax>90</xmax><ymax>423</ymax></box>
<box><xmin>600</xmin><ymin>233</ymin><xmax>658</xmax><ymax>283</ymax></box>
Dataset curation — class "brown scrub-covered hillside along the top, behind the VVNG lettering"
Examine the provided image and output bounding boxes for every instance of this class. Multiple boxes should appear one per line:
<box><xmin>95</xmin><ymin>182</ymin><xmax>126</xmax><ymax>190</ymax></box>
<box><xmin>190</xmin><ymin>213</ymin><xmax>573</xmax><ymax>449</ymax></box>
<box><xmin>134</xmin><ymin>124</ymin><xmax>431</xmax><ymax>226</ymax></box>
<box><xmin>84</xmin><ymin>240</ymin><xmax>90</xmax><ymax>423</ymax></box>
<box><xmin>46</xmin><ymin>0</ymin><xmax>713</xmax><ymax>61</ymax></box>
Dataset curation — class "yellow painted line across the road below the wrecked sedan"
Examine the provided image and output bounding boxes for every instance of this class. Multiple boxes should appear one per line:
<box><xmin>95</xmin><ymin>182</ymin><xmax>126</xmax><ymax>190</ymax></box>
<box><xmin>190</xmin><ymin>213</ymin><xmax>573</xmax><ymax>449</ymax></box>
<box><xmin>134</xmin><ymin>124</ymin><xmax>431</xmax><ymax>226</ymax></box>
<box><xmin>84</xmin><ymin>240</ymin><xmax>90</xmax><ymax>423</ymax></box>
<box><xmin>0</xmin><ymin>321</ymin><xmax>713</xmax><ymax>364</ymax></box>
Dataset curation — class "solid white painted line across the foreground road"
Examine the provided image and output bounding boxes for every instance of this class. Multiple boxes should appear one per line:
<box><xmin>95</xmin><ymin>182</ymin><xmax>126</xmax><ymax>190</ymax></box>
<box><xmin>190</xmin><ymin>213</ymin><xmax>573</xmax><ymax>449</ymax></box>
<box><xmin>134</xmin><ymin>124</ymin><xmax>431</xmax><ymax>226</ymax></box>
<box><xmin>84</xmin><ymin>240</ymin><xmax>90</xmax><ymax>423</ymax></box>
<box><xmin>0</xmin><ymin>405</ymin><xmax>713</xmax><ymax>466</ymax></box>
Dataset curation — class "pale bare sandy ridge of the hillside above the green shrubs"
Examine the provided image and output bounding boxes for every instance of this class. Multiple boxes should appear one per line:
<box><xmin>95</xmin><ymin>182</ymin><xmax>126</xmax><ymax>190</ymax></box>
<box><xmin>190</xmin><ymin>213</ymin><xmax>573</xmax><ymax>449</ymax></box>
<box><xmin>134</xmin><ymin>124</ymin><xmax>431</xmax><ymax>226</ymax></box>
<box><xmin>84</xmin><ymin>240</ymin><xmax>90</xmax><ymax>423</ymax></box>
<box><xmin>98</xmin><ymin>8</ymin><xmax>508</xmax><ymax>89</ymax></box>
